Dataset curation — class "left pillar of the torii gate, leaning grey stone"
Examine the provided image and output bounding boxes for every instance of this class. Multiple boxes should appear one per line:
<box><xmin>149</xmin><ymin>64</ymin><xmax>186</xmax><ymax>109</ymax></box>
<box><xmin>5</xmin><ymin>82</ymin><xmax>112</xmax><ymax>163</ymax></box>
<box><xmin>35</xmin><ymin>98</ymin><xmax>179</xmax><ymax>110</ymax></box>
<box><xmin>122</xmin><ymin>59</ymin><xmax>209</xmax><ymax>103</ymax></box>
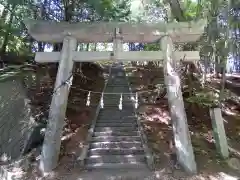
<box><xmin>40</xmin><ymin>36</ymin><xmax>77</xmax><ymax>173</ymax></box>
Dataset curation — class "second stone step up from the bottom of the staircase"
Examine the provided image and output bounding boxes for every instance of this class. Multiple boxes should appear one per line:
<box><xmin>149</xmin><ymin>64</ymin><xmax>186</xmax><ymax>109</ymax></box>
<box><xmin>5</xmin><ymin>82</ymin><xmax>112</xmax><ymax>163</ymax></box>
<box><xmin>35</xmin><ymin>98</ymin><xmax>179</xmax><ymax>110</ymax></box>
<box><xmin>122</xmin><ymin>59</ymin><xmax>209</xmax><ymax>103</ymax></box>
<box><xmin>86</xmin><ymin>155</ymin><xmax>146</xmax><ymax>164</ymax></box>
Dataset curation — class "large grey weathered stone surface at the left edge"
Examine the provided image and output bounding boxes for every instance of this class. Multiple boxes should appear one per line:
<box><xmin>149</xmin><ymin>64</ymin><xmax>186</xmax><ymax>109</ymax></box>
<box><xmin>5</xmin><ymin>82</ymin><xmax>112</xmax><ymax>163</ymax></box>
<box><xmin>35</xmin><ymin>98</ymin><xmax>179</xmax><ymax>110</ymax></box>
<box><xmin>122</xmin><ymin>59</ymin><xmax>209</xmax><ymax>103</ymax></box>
<box><xmin>0</xmin><ymin>77</ymin><xmax>31</xmax><ymax>160</ymax></box>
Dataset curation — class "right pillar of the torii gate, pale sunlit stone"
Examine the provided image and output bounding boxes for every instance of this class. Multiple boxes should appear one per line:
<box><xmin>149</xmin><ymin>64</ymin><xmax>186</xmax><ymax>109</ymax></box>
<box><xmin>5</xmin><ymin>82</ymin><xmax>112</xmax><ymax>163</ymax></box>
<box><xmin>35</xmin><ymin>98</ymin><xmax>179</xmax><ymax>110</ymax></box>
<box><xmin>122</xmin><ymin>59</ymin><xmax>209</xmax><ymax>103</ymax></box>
<box><xmin>160</xmin><ymin>36</ymin><xmax>197</xmax><ymax>174</ymax></box>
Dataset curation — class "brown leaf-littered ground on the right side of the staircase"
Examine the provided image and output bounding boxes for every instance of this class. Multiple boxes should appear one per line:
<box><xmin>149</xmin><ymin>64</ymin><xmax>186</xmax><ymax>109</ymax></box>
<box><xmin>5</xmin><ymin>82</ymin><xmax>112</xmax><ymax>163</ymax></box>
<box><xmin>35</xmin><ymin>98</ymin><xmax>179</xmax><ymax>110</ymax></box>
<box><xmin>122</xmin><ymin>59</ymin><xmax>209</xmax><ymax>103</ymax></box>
<box><xmin>124</xmin><ymin>67</ymin><xmax>240</xmax><ymax>179</ymax></box>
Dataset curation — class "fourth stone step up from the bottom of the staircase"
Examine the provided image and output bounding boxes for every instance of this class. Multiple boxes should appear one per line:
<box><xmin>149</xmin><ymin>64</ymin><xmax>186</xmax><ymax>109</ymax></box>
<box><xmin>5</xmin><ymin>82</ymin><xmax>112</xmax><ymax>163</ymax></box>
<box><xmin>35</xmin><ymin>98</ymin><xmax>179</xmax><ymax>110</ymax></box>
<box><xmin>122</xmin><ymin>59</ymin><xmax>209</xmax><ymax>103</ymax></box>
<box><xmin>90</xmin><ymin>141</ymin><xmax>142</xmax><ymax>149</ymax></box>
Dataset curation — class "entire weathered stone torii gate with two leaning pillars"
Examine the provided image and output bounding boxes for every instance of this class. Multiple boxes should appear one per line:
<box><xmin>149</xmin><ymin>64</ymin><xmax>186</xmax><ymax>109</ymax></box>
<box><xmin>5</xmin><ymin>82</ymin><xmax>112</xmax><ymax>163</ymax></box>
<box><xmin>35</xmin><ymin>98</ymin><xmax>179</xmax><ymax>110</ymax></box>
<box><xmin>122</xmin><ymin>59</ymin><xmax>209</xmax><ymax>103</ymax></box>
<box><xmin>25</xmin><ymin>20</ymin><xmax>205</xmax><ymax>173</ymax></box>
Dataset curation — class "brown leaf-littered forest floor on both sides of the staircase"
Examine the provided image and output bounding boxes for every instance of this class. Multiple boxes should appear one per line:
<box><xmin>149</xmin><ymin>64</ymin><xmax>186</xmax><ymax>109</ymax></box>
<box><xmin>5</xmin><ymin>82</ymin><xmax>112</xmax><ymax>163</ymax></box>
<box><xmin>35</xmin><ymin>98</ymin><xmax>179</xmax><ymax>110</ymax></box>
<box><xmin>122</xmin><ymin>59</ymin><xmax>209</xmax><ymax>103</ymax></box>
<box><xmin>5</xmin><ymin>64</ymin><xmax>240</xmax><ymax>180</ymax></box>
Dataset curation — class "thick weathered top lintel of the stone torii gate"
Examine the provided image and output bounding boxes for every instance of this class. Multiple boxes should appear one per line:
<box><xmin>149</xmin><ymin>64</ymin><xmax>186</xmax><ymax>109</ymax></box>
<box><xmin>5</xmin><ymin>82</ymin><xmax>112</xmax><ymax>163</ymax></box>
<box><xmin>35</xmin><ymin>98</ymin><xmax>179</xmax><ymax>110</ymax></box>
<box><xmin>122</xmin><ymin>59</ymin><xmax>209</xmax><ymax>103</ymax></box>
<box><xmin>25</xmin><ymin>20</ymin><xmax>206</xmax><ymax>43</ymax></box>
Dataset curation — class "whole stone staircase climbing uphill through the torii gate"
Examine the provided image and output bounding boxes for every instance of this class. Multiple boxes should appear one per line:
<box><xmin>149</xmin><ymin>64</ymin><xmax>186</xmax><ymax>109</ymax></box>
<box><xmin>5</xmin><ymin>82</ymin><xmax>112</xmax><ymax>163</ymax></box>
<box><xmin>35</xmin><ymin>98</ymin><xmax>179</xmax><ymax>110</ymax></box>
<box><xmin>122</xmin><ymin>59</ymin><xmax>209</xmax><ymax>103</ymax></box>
<box><xmin>85</xmin><ymin>63</ymin><xmax>152</xmax><ymax>169</ymax></box>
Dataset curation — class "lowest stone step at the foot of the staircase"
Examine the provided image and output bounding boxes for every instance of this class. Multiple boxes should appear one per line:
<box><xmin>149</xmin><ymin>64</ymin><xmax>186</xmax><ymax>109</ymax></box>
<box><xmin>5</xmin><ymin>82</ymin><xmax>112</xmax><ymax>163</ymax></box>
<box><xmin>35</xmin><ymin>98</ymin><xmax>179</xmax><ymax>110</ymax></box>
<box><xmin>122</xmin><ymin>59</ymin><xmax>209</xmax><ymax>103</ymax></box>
<box><xmin>86</xmin><ymin>163</ymin><xmax>147</xmax><ymax>171</ymax></box>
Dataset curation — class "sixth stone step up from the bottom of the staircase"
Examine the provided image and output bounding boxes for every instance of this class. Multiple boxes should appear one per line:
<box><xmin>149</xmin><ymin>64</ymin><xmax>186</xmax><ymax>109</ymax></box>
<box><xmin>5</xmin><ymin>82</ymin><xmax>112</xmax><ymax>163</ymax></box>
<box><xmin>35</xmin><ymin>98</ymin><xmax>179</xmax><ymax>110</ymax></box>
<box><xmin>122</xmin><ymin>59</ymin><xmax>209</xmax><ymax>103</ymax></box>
<box><xmin>93</xmin><ymin>130</ymin><xmax>140</xmax><ymax>136</ymax></box>
